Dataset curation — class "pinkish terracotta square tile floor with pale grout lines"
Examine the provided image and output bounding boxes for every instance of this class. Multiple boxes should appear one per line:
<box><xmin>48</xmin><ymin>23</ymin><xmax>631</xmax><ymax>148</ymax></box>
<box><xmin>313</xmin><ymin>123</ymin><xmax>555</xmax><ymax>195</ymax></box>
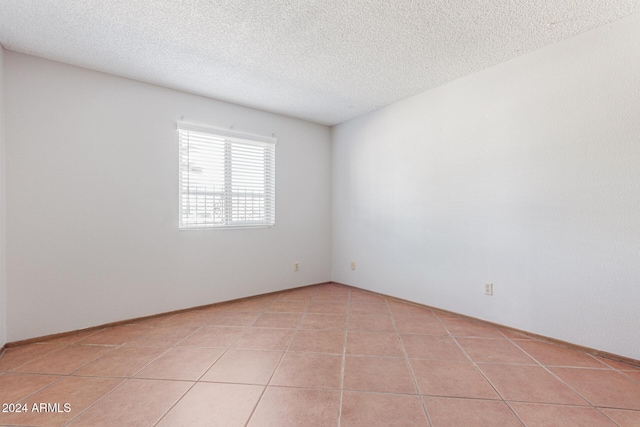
<box><xmin>0</xmin><ymin>284</ymin><xmax>640</xmax><ymax>427</ymax></box>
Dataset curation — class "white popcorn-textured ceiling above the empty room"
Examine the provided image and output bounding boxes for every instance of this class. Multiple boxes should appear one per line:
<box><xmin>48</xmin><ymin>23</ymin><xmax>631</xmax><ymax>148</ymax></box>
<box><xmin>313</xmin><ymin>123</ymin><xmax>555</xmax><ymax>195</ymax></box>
<box><xmin>0</xmin><ymin>0</ymin><xmax>640</xmax><ymax>125</ymax></box>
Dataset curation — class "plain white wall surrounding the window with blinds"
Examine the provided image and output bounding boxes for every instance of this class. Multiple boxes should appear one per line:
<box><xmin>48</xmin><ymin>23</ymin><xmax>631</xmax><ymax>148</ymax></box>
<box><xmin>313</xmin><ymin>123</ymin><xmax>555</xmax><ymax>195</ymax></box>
<box><xmin>5</xmin><ymin>51</ymin><xmax>331</xmax><ymax>342</ymax></box>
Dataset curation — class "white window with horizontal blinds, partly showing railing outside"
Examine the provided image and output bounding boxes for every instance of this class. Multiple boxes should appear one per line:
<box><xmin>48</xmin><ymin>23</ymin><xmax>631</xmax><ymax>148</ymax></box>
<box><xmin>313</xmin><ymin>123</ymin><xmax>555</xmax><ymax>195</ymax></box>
<box><xmin>178</xmin><ymin>123</ymin><xmax>276</xmax><ymax>229</ymax></box>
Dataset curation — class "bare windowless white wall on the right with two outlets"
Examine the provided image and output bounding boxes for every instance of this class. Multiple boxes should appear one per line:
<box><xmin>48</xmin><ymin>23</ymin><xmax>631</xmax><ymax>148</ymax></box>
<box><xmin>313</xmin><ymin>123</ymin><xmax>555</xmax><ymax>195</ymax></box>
<box><xmin>332</xmin><ymin>15</ymin><xmax>640</xmax><ymax>359</ymax></box>
